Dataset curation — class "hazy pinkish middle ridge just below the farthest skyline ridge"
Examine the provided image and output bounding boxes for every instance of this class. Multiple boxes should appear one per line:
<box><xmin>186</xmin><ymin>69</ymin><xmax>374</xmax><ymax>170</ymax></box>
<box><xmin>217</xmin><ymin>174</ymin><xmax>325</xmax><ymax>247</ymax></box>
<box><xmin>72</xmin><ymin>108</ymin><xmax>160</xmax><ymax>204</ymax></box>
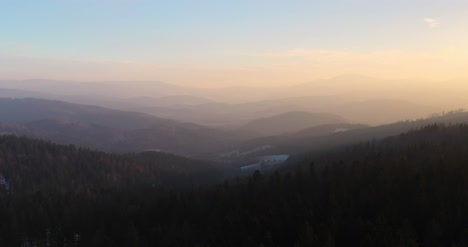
<box><xmin>129</xmin><ymin>96</ymin><xmax>440</xmax><ymax>128</ymax></box>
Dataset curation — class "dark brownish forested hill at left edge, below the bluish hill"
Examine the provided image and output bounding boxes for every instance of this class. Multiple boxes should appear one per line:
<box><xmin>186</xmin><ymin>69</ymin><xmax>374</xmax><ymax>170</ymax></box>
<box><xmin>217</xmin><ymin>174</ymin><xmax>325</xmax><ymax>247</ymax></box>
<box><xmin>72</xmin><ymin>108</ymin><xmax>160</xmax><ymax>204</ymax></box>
<box><xmin>0</xmin><ymin>136</ymin><xmax>219</xmax><ymax>193</ymax></box>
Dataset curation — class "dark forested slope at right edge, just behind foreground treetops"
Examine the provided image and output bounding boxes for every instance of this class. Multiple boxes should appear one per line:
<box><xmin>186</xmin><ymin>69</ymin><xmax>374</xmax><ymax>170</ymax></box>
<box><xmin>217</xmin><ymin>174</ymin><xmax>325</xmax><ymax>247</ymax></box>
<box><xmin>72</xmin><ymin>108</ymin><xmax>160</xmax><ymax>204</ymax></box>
<box><xmin>295</xmin><ymin>123</ymin><xmax>468</xmax><ymax>163</ymax></box>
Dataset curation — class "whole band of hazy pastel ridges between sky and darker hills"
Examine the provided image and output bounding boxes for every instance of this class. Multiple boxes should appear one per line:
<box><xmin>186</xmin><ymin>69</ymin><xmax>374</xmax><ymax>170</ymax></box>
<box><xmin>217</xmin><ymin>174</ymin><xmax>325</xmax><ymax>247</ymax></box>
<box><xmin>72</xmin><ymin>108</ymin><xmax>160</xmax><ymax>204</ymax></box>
<box><xmin>0</xmin><ymin>75</ymin><xmax>446</xmax><ymax>129</ymax></box>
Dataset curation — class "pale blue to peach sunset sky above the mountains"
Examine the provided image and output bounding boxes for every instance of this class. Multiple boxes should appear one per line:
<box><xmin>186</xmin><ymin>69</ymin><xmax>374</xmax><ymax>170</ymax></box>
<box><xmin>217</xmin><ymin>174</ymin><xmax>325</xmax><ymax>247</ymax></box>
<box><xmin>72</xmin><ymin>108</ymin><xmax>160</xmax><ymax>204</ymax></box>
<box><xmin>0</xmin><ymin>0</ymin><xmax>468</xmax><ymax>87</ymax></box>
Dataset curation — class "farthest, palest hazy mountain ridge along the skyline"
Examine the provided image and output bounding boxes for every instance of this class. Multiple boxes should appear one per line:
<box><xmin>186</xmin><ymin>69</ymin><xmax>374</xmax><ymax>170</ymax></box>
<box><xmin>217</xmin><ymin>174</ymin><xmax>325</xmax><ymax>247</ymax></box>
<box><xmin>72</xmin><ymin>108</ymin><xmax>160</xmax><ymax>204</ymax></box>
<box><xmin>0</xmin><ymin>75</ymin><xmax>468</xmax><ymax>106</ymax></box>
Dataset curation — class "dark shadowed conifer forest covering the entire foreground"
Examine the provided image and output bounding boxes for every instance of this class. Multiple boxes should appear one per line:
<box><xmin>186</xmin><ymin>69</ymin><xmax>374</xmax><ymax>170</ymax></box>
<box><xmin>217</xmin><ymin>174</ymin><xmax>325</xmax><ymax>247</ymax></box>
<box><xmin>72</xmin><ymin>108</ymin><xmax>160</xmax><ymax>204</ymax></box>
<box><xmin>0</xmin><ymin>125</ymin><xmax>468</xmax><ymax>247</ymax></box>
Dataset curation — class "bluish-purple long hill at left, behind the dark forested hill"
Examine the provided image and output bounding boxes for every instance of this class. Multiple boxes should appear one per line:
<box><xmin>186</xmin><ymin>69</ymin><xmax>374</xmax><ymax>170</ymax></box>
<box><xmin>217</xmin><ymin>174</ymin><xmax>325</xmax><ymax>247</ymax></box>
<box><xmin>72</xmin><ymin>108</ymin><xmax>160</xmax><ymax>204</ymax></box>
<box><xmin>0</xmin><ymin>99</ymin><xmax>235</xmax><ymax>155</ymax></box>
